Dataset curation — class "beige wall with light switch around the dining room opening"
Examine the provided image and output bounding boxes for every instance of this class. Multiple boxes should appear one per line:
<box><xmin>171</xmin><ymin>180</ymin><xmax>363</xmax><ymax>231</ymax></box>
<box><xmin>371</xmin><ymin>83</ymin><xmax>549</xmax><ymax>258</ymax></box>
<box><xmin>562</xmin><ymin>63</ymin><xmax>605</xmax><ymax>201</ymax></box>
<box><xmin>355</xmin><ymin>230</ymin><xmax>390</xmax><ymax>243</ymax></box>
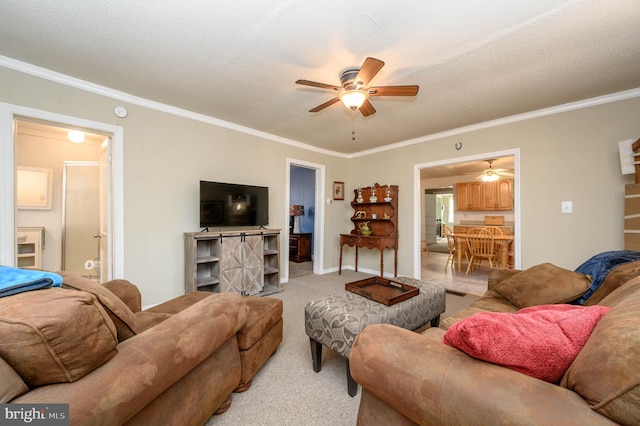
<box><xmin>350</xmin><ymin>98</ymin><xmax>640</xmax><ymax>274</ymax></box>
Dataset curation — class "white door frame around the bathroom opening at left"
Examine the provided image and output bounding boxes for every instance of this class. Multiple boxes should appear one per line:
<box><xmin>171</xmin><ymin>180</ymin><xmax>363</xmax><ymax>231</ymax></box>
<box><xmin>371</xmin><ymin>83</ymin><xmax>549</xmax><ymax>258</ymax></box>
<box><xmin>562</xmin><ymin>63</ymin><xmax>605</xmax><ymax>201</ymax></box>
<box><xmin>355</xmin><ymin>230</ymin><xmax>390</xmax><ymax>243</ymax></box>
<box><xmin>0</xmin><ymin>102</ymin><xmax>124</xmax><ymax>279</ymax></box>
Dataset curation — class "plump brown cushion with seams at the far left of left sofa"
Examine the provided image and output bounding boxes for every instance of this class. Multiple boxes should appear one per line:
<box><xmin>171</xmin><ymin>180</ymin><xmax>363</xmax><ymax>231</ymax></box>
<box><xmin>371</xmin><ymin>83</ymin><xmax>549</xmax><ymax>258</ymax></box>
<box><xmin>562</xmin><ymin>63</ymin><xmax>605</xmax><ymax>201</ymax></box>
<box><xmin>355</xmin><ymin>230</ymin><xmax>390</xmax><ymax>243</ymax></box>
<box><xmin>0</xmin><ymin>288</ymin><xmax>118</xmax><ymax>388</ymax></box>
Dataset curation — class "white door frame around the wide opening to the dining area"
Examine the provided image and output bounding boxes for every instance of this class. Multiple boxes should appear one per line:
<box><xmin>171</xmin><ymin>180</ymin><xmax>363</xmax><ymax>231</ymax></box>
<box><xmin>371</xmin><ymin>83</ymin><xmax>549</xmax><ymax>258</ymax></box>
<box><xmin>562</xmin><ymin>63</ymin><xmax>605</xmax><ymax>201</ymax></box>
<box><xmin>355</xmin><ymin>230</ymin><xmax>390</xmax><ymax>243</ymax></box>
<box><xmin>413</xmin><ymin>148</ymin><xmax>522</xmax><ymax>278</ymax></box>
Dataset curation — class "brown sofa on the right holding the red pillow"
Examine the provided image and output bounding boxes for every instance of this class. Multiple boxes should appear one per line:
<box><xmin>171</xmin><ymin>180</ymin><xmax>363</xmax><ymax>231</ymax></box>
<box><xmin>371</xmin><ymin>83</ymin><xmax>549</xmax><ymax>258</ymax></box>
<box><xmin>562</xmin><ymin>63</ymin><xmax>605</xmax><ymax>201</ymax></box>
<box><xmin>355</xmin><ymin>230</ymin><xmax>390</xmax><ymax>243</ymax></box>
<box><xmin>350</xmin><ymin>262</ymin><xmax>640</xmax><ymax>425</ymax></box>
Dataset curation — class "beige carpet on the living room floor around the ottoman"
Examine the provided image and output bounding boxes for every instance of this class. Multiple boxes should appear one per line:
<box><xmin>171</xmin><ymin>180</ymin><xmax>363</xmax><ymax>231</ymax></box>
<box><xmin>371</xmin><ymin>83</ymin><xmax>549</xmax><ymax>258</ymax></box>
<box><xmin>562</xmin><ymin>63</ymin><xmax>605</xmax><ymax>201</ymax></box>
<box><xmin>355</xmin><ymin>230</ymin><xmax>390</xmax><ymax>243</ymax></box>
<box><xmin>207</xmin><ymin>270</ymin><xmax>477</xmax><ymax>426</ymax></box>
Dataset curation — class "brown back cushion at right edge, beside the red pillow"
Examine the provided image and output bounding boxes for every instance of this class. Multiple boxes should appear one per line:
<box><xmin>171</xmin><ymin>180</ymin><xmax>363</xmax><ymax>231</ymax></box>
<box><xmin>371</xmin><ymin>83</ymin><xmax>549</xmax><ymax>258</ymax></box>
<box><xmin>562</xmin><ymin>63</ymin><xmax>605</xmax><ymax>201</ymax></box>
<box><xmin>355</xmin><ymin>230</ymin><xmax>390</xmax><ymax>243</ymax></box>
<box><xmin>560</xmin><ymin>277</ymin><xmax>640</xmax><ymax>425</ymax></box>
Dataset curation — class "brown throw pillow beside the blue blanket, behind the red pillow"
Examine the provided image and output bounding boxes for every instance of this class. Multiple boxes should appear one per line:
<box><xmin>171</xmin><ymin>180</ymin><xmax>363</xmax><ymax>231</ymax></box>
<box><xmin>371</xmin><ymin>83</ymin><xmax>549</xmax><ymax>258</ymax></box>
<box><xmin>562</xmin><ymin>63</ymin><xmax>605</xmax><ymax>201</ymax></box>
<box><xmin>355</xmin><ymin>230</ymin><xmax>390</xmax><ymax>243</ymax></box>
<box><xmin>493</xmin><ymin>263</ymin><xmax>591</xmax><ymax>308</ymax></box>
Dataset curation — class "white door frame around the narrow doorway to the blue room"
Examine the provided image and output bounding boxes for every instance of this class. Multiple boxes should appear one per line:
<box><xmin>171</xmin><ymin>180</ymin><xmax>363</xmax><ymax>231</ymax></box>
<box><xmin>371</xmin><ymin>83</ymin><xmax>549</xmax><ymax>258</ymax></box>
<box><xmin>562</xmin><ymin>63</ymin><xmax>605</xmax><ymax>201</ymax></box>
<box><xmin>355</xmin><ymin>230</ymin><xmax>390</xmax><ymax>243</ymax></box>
<box><xmin>280</xmin><ymin>158</ymin><xmax>325</xmax><ymax>282</ymax></box>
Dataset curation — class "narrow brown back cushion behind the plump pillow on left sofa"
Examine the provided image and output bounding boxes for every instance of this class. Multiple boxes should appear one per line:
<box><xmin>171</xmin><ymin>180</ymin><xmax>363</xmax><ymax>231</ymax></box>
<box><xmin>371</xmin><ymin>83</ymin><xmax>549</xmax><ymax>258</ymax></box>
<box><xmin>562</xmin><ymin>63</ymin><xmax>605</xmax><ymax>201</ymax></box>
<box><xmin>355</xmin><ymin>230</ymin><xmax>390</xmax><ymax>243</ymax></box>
<box><xmin>59</xmin><ymin>272</ymin><xmax>142</xmax><ymax>342</ymax></box>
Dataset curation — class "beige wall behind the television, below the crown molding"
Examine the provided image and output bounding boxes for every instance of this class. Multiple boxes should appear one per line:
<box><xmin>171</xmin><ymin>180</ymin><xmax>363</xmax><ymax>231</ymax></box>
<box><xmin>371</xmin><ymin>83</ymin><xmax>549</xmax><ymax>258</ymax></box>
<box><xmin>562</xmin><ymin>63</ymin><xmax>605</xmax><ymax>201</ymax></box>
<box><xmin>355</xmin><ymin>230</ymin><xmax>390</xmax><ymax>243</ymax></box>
<box><xmin>0</xmin><ymin>68</ymin><xmax>348</xmax><ymax>305</ymax></box>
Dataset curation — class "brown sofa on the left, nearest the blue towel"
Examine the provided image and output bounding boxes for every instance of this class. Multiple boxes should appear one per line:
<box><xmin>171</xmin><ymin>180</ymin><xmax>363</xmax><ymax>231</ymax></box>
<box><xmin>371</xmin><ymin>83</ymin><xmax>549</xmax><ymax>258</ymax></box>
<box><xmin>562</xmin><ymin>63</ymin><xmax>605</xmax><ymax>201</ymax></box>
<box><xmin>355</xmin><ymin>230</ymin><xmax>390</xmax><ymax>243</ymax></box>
<box><xmin>0</xmin><ymin>272</ymin><xmax>282</xmax><ymax>425</ymax></box>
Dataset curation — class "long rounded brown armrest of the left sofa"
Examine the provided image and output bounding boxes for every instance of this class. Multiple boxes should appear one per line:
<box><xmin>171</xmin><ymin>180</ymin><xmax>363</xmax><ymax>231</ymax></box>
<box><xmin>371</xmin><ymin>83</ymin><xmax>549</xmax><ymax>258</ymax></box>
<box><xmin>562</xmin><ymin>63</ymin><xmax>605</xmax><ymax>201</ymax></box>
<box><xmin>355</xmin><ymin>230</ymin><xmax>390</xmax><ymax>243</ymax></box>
<box><xmin>11</xmin><ymin>293</ymin><xmax>247</xmax><ymax>425</ymax></box>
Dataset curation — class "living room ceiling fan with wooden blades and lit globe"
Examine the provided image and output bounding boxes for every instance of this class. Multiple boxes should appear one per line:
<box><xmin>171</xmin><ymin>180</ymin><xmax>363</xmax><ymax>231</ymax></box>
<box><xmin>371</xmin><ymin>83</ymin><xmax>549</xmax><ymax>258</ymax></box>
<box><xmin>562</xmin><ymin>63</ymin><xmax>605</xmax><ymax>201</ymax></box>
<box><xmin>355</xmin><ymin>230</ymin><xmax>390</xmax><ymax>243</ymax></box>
<box><xmin>296</xmin><ymin>58</ymin><xmax>419</xmax><ymax>117</ymax></box>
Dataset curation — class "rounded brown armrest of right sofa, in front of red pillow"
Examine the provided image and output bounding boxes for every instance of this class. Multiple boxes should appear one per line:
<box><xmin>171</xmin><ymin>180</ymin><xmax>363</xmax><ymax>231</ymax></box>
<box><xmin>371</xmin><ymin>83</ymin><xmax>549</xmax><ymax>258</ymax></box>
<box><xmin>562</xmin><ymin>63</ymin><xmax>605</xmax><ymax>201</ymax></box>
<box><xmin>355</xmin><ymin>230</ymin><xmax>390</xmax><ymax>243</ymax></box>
<box><xmin>349</xmin><ymin>324</ymin><xmax>613</xmax><ymax>425</ymax></box>
